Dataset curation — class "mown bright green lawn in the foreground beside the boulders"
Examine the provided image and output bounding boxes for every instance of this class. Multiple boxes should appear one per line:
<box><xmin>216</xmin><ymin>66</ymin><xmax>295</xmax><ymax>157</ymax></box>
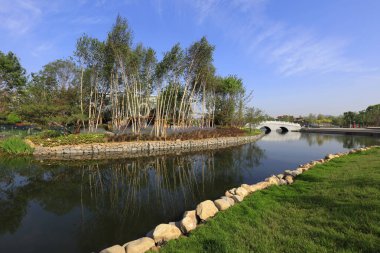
<box><xmin>162</xmin><ymin>148</ymin><xmax>380</xmax><ymax>252</ymax></box>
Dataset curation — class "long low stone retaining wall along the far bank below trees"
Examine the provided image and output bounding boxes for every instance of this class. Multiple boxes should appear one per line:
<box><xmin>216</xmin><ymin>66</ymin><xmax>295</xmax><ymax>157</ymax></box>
<box><xmin>28</xmin><ymin>133</ymin><xmax>265</xmax><ymax>160</ymax></box>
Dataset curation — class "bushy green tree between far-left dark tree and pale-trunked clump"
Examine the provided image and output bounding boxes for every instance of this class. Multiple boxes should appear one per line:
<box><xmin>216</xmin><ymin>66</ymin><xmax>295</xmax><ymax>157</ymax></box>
<box><xmin>17</xmin><ymin>60</ymin><xmax>80</xmax><ymax>126</ymax></box>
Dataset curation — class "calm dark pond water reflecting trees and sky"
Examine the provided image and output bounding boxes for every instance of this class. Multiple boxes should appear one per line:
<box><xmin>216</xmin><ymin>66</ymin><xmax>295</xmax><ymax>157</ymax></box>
<box><xmin>0</xmin><ymin>132</ymin><xmax>380</xmax><ymax>252</ymax></box>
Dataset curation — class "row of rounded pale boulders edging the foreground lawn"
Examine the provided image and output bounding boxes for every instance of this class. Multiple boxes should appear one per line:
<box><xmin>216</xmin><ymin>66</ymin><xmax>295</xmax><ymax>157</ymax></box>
<box><xmin>100</xmin><ymin>146</ymin><xmax>379</xmax><ymax>253</ymax></box>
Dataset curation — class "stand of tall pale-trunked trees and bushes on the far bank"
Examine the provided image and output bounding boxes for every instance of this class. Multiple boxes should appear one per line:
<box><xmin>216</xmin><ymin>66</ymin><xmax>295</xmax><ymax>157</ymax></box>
<box><xmin>0</xmin><ymin>16</ymin><xmax>262</xmax><ymax>137</ymax></box>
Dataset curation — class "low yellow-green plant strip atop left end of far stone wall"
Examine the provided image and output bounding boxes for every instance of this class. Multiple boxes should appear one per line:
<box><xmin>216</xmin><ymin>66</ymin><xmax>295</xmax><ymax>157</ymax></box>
<box><xmin>28</xmin><ymin>133</ymin><xmax>106</xmax><ymax>147</ymax></box>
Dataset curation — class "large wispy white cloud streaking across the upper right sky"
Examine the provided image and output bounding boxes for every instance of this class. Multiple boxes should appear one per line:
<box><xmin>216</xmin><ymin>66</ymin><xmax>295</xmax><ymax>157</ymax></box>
<box><xmin>183</xmin><ymin>0</ymin><xmax>373</xmax><ymax>76</ymax></box>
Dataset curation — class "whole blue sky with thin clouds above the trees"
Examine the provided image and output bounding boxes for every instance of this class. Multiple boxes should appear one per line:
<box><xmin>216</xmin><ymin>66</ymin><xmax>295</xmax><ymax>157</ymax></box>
<box><xmin>0</xmin><ymin>0</ymin><xmax>380</xmax><ymax>116</ymax></box>
